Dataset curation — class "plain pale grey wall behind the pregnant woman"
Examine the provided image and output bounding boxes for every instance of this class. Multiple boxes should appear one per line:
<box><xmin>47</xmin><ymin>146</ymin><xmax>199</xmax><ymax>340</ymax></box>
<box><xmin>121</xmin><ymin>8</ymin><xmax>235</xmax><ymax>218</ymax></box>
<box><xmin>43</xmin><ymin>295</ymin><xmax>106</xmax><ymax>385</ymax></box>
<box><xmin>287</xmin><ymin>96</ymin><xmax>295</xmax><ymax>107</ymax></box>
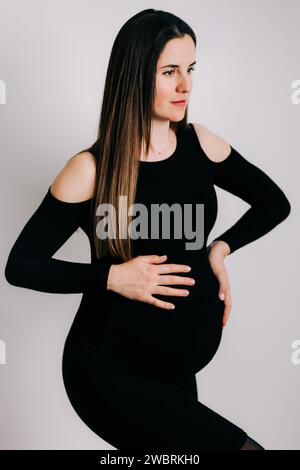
<box><xmin>0</xmin><ymin>0</ymin><xmax>300</xmax><ymax>449</ymax></box>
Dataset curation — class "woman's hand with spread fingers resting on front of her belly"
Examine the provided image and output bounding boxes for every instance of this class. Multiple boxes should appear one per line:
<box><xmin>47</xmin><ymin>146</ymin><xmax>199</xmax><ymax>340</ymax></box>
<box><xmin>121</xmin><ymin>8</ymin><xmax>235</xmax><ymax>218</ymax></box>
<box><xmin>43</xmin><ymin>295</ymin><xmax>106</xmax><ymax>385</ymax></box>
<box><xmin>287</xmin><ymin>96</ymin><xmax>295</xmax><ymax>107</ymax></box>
<box><xmin>107</xmin><ymin>255</ymin><xmax>195</xmax><ymax>309</ymax></box>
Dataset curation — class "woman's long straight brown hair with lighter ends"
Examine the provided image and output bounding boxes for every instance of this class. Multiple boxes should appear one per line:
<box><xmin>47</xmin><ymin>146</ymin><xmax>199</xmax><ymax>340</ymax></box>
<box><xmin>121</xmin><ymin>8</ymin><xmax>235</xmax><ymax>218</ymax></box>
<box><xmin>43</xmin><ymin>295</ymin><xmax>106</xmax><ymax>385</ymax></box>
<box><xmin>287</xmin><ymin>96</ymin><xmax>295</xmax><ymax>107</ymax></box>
<box><xmin>84</xmin><ymin>9</ymin><xmax>196</xmax><ymax>261</ymax></box>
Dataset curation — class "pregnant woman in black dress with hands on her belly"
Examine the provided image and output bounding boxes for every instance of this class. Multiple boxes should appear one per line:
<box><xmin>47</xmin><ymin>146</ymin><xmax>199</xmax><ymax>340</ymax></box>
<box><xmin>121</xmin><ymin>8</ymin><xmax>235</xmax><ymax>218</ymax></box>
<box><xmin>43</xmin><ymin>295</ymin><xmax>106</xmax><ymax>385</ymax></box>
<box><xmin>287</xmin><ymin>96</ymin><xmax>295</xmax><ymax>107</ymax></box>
<box><xmin>5</xmin><ymin>9</ymin><xmax>290</xmax><ymax>450</ymax></box>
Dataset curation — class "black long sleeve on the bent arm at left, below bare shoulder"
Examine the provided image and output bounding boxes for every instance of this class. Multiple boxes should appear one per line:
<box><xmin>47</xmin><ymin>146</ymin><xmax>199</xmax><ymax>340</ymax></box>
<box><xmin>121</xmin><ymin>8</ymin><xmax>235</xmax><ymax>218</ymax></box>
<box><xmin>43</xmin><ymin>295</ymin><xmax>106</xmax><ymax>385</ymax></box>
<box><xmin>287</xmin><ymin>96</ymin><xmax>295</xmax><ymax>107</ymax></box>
<box><xmin>5</xmin><ymin>187</ymin><xmax>111</xmax><ymax>294</ymax></box>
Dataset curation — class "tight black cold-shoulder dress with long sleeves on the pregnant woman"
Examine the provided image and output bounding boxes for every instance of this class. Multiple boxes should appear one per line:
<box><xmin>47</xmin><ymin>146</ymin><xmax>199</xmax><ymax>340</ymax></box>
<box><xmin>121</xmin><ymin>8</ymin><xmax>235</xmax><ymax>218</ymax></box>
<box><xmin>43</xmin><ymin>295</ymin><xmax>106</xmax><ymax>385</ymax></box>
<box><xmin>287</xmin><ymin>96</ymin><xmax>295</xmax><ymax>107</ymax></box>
<box><xmin>5</xmin><ymin>124</ymin><xmax>290</xmax><ymax>450</ymax></box>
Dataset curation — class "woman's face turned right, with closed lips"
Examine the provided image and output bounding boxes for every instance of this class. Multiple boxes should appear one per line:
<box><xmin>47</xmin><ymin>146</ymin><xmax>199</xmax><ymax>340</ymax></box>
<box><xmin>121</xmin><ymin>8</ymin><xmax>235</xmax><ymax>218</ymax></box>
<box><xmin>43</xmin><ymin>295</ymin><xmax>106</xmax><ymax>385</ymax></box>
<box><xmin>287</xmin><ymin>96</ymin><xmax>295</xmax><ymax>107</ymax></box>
<box><xmin>154</xmin><ymin>35</ymin><xmax>195</xmax><ymax>121</ymax></box>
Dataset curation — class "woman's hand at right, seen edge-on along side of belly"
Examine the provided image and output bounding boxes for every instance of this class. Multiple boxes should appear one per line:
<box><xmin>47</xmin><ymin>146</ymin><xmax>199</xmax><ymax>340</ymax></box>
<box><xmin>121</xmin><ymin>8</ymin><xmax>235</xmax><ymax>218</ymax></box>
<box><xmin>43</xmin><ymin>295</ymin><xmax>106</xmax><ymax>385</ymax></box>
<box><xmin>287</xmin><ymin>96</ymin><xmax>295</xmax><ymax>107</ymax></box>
<box><xmin>208</xmin><ymin>240</ymin><xmax>232</xmax><ymax>328</ymax></box>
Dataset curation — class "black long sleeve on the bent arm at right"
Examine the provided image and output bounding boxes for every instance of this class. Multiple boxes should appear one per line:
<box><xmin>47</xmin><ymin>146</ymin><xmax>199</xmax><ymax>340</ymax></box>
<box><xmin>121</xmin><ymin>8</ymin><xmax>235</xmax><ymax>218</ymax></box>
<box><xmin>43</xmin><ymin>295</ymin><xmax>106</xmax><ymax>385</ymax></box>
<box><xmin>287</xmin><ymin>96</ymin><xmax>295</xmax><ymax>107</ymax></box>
<box><xmin>210</xmin><ymin>146</ymin><xmax>291</xmax><ymax>254</ymax></box>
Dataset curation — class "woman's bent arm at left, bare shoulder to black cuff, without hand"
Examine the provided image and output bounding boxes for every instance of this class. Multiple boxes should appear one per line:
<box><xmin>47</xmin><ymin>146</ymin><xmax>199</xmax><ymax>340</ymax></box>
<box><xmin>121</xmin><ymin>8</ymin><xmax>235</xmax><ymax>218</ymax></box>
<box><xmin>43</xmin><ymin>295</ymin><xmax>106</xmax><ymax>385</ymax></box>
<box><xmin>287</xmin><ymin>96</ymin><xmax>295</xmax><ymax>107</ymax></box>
<box><xmin>5</xmin><ymin>152</ymin><xmax>111</xmax><ymax>294</ymax></box>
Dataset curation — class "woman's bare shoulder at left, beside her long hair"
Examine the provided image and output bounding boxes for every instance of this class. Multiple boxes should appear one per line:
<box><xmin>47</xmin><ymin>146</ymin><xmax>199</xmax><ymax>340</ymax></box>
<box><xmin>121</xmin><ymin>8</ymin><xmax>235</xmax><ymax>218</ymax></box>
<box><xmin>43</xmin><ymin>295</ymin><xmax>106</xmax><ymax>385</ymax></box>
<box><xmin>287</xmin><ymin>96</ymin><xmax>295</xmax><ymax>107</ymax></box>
<box><xmin>51</xmin><ymin>151</ymin><xmax>96</xmax><ymax>202</ymax></box>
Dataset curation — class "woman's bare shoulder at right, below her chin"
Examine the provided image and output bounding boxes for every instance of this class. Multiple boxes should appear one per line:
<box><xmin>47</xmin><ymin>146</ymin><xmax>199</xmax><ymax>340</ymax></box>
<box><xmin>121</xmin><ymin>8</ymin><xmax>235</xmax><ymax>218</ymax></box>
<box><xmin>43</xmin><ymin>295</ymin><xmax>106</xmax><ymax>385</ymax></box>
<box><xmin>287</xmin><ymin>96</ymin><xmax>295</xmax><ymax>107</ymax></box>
<box><xmin>193</xmin><ymin>122</ymin><xmax>231</xmax><ymax>163</ymax></box>
